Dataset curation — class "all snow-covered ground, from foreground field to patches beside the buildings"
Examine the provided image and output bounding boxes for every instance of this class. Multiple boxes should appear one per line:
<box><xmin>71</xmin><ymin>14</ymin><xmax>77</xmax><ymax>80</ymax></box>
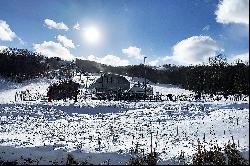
<box><xmin>0</xmin><ymin>77</ymin><xmax>249</xmax><ymax>164</ymax></box>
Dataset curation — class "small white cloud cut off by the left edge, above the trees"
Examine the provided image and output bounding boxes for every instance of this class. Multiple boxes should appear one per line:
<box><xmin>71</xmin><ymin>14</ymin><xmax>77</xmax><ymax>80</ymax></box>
<box><xmin>0</xmin><ymin>20</ymin><xmax>17</xmax><ymax>41</ymax></box>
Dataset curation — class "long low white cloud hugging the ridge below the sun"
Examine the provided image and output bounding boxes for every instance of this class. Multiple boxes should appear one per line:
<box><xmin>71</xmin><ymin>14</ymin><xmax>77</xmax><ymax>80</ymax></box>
<box><xmin>87</xmin><ymin>55</ymin><xmax>129</xmax><ymax>66</ymax></box>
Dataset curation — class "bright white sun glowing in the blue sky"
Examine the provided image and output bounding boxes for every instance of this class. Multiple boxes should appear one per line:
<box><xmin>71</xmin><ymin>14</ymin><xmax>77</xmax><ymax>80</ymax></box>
<box><xmin>84</xmin><ymin>26</ymin><xmax>101</xmax><ymax>44</ymax></box>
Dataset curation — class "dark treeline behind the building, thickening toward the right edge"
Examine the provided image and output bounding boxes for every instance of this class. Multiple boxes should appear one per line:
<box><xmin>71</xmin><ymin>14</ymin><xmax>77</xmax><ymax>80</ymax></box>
<box><xmin>76</xmin><ymin>54</ymin><xmax>249</xmax><ymax>95</ymax></box>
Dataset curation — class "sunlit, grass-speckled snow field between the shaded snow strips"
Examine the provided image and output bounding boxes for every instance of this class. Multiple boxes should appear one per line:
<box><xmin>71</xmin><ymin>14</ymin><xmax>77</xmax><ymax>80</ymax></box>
<box><xmin>0</xmin><ymin>102</ymin><xmax>249</xmax><ymax>164</ymax></box>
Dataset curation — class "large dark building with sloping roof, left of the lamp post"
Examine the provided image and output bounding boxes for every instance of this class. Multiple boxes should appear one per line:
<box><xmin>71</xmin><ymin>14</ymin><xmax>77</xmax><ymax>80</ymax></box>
<box><xmin>89</xmin><ymin>74</ymin><xmax>130</xmax><ymax>92</ymax></box>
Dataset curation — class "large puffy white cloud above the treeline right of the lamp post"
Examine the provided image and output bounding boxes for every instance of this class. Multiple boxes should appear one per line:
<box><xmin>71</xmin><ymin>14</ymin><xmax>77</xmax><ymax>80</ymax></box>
<box><xmin>164</xmin><ymin>36</ymin><xmax>222</xmax><ymax>65</ymax></box>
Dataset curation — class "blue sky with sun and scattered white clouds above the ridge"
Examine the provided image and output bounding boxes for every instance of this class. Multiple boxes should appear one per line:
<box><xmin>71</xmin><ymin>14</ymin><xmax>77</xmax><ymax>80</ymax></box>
<box><xmin>0</xmin><ymin>0</ymin><xmax>249</xmax><ymax>66</ymax></box>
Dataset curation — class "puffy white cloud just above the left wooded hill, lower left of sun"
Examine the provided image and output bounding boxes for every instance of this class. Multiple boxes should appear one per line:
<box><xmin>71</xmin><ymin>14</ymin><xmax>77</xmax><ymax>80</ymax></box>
<box><xmin>33</xmin><ymin>41</ymin><xmax>74</xmax><ymax>60</ymax></box>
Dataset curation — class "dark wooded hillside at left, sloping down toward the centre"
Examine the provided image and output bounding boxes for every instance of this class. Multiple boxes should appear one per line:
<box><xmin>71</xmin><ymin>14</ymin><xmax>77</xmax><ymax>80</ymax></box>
<box><xmin>0</xmin><ymin>48</ymin><xmax>74</xmax><ymax>82</ymax></box>
